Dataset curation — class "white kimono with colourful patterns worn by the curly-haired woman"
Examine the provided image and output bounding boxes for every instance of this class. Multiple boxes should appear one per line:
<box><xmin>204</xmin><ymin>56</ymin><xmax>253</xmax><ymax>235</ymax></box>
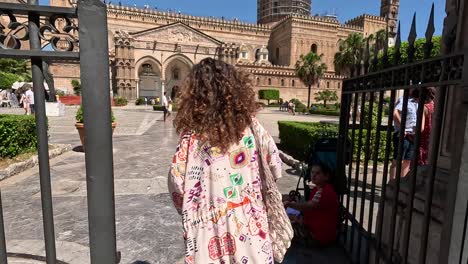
<box><xmin>169</xmin><ymin>119</ymin><xmax>281</xmax><ymax>264</ymax></box>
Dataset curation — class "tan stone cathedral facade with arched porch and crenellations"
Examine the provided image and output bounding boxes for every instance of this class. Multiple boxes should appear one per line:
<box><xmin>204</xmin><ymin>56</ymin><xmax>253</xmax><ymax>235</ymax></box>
<box><xmin>50</xmin><ymin>0</ymin><xmax>398</xmax><ymax>101</ymax></box>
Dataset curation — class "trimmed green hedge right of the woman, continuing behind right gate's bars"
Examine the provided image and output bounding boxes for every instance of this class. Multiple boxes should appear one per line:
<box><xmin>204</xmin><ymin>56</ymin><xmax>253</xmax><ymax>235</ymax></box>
<box><xmin>278</xmin><ymin>121</ymin><xmax>393</xmax><ymax>162</ymax></box>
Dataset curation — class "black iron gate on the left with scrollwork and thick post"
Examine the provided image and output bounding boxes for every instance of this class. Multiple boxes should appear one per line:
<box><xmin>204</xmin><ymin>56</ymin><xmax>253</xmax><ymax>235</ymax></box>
<box><xmin>0</xmin><ymin>0</ymin><xmax>118</xmax><ymax>264</ymax></box>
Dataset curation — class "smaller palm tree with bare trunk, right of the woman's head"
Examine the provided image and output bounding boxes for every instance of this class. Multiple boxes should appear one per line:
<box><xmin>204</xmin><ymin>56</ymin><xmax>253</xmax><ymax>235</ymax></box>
<box><xmin>296</xmin><ymin>52</ymin><xmax>327</xmax><ymax>108</ymax></box>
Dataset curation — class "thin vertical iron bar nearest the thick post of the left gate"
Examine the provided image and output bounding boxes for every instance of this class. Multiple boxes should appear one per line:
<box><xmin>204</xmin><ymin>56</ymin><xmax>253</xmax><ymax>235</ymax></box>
<box><xmin>28</xmin><ymin>0</ymin><xmax>56</xmax><ymax>264</ymax></box>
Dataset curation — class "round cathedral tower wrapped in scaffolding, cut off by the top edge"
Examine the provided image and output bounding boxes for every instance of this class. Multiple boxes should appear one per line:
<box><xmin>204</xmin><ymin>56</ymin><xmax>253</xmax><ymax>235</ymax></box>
<box><xmin>257</xmin><ymin>0</ymin><xmax>312</xmax><ymax>24</ymax></box>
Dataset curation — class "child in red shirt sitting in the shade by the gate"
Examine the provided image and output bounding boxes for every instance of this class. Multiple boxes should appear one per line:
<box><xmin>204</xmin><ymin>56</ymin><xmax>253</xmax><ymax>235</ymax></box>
<box><xmin>285</xmin><ymin>164</ymin><xmax>339</xmax><ymax>246</ymax></box>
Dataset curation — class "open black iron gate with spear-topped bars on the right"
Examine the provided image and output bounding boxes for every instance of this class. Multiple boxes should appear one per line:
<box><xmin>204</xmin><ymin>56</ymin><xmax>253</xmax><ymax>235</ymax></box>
<box><xmin>337</xmin><ymin>6</ymin><xmax>468</xmax><ymax>263</ymax></box>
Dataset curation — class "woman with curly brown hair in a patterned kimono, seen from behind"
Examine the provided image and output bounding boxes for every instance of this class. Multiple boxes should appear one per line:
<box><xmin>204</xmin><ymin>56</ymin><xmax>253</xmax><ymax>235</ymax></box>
<box><xmin>169</xmin><ymin>58</ymin><xmax>281</xmax><ymax>264</ymax></box>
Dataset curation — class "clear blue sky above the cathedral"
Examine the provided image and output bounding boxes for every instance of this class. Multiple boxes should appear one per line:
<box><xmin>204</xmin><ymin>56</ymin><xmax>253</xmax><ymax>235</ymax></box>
<box><xmin>44</xmin><ymin>0</ymin><xmax>445</xmax><ymax>40</ymax></box>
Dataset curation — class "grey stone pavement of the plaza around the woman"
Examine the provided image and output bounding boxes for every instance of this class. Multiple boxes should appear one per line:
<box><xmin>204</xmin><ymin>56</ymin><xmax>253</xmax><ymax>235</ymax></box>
<box><xmin>0</xmin><ymin>107</ymin><xmax>344</xmax><ymax>264</ymax></box>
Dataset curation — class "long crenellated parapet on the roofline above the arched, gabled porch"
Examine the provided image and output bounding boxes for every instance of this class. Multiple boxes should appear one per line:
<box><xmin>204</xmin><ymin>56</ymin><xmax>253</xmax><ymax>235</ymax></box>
<box><xmin>107</xmin><ymin>4</ymin><xmax>271</xmax><ymax>33</ymax></box>
